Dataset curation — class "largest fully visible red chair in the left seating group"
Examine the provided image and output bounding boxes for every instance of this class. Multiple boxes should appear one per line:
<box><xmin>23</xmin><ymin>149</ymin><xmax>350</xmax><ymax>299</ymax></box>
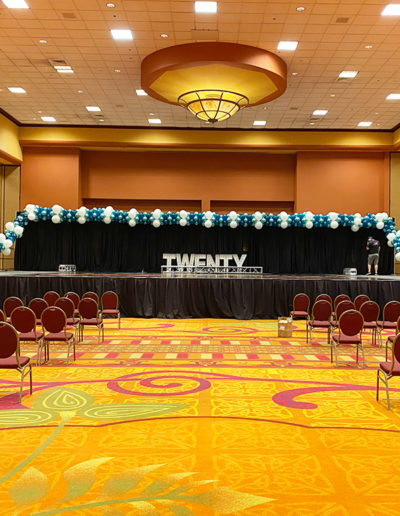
<box><xmin>42</xmin><ymin>306</ymin><xmax>75</xmax><ymax>364</ymax></box>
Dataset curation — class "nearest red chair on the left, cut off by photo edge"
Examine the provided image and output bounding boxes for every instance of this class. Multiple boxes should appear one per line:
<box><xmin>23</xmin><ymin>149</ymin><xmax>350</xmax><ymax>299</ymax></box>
<box><xmin>0</xmin><ymin>322</ymin><xmax>32</xmax><ymax>403</ymax></box>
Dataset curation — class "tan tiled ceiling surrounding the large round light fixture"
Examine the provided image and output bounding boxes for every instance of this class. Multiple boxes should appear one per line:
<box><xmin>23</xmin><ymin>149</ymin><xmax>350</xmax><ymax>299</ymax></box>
<box><xmin>0</xmin><ymin>0</ymin><xmax>400</xmax><ymax>130</ymax></box>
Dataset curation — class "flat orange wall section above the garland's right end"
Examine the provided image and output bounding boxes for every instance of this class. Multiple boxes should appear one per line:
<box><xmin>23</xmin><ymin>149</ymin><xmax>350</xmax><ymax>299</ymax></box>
<box><xmin>296</xmin><ymin>152</ymin><xmax>389</xmax><ymax>215</ymax></box>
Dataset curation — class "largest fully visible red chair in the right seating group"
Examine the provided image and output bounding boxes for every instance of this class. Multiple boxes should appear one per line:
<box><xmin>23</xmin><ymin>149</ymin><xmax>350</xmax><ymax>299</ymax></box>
<box><xmin>331</xmin><ymin>310</ymin><xmax>366</xmax><ymax>367</ymax></box>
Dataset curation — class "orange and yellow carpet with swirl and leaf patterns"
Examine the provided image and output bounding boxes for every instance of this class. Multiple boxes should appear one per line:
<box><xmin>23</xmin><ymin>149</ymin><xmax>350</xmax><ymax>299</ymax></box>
<box><xmin>0</xmin><ymin>319</ymin><xmax>400</xmax><ymax>516</ymax></box>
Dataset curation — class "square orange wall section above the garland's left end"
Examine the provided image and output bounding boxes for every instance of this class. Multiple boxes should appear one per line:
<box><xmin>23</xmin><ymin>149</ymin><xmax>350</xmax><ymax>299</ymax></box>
<box><xmin>21</xmin><ymin>147</ymin><xmax>81</xmax><ymax>209</ymax></box>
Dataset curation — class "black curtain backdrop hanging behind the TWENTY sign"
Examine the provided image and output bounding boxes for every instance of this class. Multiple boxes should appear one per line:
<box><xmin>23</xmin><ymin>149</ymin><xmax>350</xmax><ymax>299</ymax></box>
<box><xmin>15</xmin><ymin>221</ymin><xmax>393</xmax><ymax>274</ymax></box>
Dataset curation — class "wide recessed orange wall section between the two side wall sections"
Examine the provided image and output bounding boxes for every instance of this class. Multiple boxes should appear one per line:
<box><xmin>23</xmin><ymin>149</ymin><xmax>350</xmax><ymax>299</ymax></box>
<box><xmin>81</xmin><ymin>151</ymin><xmax>296</xmax><ymax>213</ymax></box>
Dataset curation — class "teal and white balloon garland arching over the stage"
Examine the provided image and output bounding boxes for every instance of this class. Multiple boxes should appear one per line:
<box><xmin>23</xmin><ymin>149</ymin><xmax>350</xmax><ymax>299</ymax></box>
<box><xmin>0</xmin><ymin>204</ymin><xmax>400</xmax><ymax>261</ymax></box>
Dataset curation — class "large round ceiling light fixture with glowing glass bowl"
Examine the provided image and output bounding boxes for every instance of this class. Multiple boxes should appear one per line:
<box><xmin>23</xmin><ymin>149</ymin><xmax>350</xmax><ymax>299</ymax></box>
<box><xmin>141</xmin><ymin>42</ymin><xmax>287</xmax><ymax>123</ymax></box>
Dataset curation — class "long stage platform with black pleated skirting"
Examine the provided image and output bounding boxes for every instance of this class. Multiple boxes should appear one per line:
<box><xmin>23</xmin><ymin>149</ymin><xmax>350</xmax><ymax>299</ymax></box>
<box><xmin>0</xmin><ymin>271</ymin><xmax>400</xmax><ymax>319</ymax></box>
